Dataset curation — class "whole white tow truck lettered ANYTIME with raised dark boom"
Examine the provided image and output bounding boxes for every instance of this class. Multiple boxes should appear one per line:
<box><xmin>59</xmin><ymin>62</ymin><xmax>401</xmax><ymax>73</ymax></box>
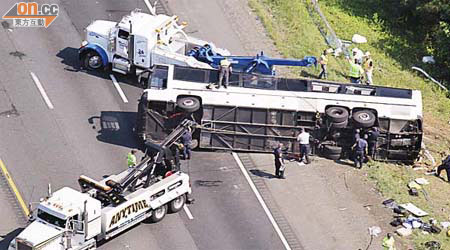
<box><xmin>9</xmin><ymin>120</ymin><xmax>194</xmax><ymax>250</ymax></box>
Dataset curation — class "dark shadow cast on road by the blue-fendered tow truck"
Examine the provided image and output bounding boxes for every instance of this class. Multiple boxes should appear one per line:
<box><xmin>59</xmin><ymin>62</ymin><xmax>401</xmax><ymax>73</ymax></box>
<box><xmin>56</xmin><ymin>47</ymin><xmax>142</xmax><ymax>88</ymax></box>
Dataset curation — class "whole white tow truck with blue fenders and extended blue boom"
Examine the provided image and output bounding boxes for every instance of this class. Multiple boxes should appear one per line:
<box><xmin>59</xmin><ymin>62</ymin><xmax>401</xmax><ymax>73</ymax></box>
<box><xmin>78</xmin><ymin>4</ymin><xmax>317</xmax><ymax>76</ymax></box>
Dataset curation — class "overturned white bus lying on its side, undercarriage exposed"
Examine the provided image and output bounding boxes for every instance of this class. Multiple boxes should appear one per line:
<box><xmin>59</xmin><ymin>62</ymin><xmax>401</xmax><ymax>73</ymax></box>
<box><xmin>136</xmin><ymin>65</ymin><xmax>422</xmax><ymax>162</ymax></box>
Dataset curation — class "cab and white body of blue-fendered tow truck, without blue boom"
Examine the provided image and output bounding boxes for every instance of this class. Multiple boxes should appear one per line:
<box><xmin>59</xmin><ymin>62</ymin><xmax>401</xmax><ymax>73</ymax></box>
<box><xmin>78</xmin><ymin>3</ymin><xmax>230</xmax><ymax>75</ymax></box>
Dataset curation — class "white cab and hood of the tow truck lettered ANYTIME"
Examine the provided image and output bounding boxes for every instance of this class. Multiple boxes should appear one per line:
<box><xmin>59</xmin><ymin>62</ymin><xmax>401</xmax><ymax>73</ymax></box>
<box><xmin>9</xmin><ymin>187</ymin><xmax>101</xmax><ymax>250</ymax></box>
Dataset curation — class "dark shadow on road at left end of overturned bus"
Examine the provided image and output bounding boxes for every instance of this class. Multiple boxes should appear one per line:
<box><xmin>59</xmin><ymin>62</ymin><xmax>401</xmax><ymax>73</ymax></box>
<box><xmin>88</xmin><ymin>111</ymin><xmax>142</xmax><ymax>149</ymax></box>
